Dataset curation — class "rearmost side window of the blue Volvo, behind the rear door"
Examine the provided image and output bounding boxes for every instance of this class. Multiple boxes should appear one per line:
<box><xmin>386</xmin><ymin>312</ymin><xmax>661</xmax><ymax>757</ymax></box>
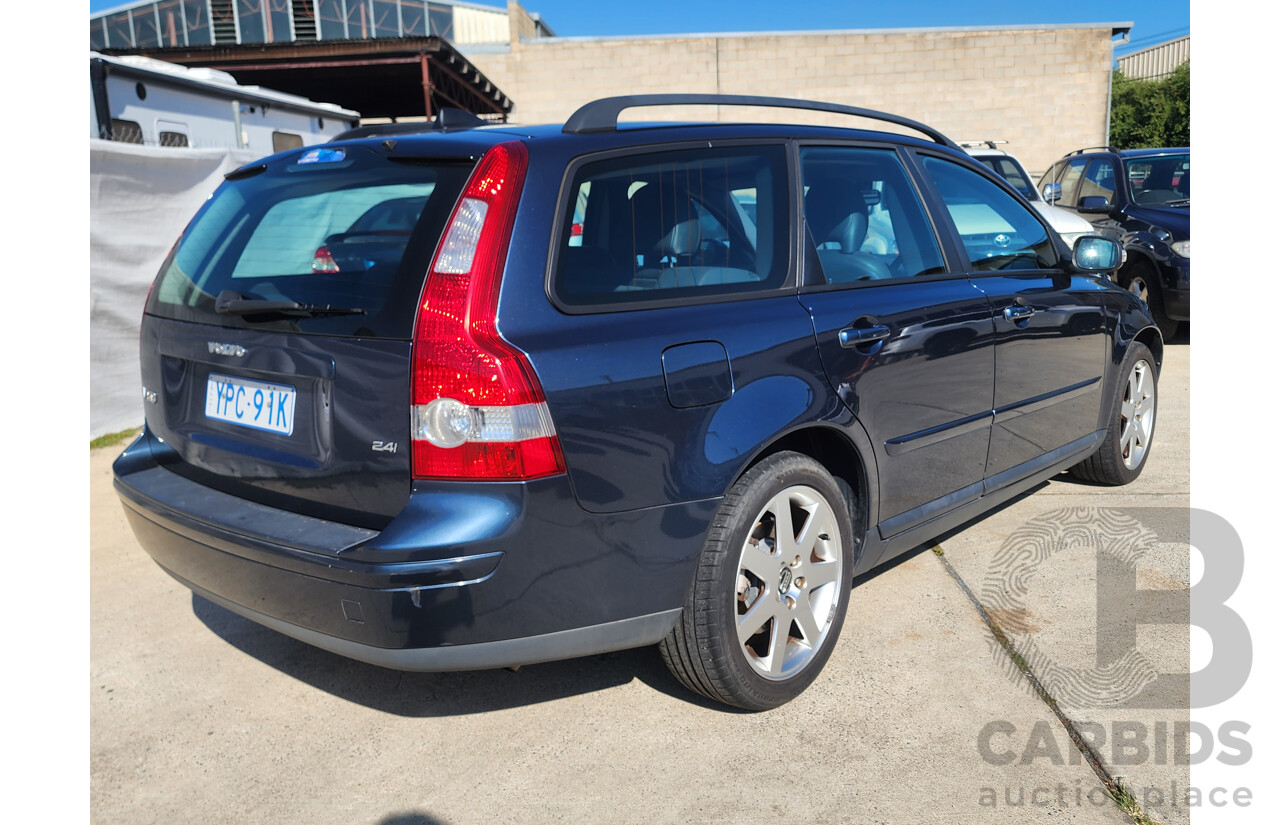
<box><xmin>552</xmin><ymin>145</ymin><xmax>788</xmax><ymax>306</ymax></box>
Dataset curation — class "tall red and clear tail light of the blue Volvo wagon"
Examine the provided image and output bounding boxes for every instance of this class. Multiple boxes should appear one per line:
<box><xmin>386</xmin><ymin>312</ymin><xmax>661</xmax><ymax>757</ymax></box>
<box><xmin>412</xmin><ymin>142</ymin><xmax>564</xmax><ymax>480</ymax></box>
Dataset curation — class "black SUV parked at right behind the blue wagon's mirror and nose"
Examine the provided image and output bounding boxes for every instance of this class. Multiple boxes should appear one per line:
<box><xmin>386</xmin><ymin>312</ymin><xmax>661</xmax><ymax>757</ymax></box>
<box><xmin>1039</xmin><ymin>147</ymin><xmax>1192</xmax><ymax>338</ymax></box>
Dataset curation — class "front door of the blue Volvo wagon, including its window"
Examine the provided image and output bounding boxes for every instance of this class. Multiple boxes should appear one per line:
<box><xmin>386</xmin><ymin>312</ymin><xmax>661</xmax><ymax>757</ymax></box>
<box><xmin>920</xmin><ymin>155</ymin><xmax>1107</xmax><ymax>489</ymax></box>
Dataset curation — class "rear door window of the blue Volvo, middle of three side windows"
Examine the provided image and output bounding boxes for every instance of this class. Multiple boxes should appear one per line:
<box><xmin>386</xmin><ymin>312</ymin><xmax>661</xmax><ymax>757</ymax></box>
<box><xmin>800</xmin><ymin>147</ymin><xmax>946</xmax><ymax>284</ymax></box>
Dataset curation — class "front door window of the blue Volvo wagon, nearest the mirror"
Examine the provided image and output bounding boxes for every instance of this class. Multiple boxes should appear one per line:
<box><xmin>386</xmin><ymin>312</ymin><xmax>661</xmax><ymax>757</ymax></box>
<box><xmin>922</xmin><ymin>156</ymin><xmax>1065</xmax><ymax>271</ymax></box>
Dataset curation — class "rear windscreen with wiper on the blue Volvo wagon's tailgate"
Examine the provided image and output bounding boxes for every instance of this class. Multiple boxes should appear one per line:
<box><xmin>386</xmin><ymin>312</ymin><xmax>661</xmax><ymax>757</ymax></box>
<box><xmin>147</xmin><ymin>146</ymin><xmax>471</xmax><ymax>339</ymax></box>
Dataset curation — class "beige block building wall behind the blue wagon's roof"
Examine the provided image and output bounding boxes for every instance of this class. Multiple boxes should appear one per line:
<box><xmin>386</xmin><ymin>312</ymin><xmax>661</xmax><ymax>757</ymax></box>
<box><xmin>468</xmin><ymin>16</ymin><xmax>1112</xmax><ymax>171</ymax></box>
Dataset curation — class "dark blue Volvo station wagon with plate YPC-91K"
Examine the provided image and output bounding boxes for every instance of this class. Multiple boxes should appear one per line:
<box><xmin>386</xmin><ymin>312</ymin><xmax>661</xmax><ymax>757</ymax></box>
<box><xmin>115</xmin><ymin>95</ymin><xmax>1162</xmax><ymax>709</ymax></box>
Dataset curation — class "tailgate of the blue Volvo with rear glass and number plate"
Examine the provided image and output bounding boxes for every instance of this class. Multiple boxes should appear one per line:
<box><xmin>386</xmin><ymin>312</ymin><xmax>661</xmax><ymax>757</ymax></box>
<box><xmin>141</xmin><ymin>142</ymin><xmax>474</xmax><ymax>528</ymax></box>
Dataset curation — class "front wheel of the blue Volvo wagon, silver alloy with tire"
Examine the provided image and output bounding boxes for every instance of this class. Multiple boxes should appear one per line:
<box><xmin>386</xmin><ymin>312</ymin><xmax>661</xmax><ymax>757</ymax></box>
<box><xmin>1071</xmin><ymin>342</ymin><xmax>1158</xmax><ymax>486</ymax></box>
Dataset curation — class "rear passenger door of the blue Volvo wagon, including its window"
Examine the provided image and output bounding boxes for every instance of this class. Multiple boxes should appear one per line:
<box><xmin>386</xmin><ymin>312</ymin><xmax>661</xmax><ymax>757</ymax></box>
<box><xmin>800</xmin><ymin>146</ymin><xmax>995</xmax><ymax>537</ymax></box>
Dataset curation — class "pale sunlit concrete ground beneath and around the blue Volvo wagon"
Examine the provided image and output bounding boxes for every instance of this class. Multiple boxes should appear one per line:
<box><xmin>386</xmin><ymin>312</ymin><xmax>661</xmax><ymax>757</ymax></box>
<box><xmin>90</xmin><ymin>343</ymin><xmax>1190</xmax><ymax>825</ymax></box>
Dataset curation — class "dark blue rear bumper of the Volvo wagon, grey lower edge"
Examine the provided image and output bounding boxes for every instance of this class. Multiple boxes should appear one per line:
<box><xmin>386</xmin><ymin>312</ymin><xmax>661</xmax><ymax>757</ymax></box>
<box><xmin>115</xmin><ymin>435</ymin><xmax>718</xmax><ymax>670</ymax></box>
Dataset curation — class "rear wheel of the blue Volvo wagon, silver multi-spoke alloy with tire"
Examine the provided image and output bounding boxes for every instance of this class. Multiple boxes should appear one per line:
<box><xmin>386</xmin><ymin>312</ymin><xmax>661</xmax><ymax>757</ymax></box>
<box><xmin>659</xmin><ymin>453</ymin><xmax>855</xmax><ymax>710</ymax></box>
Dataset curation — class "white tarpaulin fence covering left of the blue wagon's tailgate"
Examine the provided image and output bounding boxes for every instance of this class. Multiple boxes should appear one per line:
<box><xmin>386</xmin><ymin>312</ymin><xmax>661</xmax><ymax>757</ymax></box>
<box><xmin>90</xmin><ymin>139</ymin><xmax>255</xmax><ymax>439</ymax></box>
